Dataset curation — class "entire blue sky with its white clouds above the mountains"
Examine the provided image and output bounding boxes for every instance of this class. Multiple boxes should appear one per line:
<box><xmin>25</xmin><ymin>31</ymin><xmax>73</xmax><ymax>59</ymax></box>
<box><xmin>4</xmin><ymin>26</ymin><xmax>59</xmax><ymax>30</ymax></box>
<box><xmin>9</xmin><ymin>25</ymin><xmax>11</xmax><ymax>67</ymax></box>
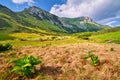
<box><xmin>0</xmin><ymin>0</ymin><xmax>120</xmax><ymax>26</ymax></box>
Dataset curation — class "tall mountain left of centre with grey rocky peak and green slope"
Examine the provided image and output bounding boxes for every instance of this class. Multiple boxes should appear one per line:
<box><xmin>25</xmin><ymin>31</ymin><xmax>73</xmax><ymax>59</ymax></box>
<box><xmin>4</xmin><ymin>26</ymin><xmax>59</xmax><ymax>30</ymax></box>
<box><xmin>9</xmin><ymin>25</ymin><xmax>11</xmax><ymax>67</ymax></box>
<box><xmin>17</xmin><ymin>7</ymin><xmax>67</xmax><ymax>33</ymax></box>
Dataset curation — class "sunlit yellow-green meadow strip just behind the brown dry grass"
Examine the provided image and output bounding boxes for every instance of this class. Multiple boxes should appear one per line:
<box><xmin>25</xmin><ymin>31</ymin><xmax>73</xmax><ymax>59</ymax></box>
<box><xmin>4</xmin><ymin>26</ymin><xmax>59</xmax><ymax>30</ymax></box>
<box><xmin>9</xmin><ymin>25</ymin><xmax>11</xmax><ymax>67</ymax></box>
<box><xmin>1</xmin><ymin>38</ymin><xmax>82</xmax><ymax>46</ymax></box>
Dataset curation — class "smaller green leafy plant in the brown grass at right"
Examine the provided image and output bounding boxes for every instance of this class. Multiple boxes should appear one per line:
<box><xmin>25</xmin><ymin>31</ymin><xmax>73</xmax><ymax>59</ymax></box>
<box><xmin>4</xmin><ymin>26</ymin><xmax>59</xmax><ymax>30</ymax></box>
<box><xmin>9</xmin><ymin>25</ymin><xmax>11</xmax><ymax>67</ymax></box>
<box><xmin>85</xmin><ymin>52</ymin><xmax>100</xmax><ymax>66</ymax></box>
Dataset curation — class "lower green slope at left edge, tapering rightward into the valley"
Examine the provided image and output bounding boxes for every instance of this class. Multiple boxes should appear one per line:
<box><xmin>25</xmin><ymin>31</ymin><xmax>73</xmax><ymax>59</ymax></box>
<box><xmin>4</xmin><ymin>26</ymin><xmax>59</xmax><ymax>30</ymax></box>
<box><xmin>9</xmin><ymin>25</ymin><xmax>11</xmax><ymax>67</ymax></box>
<box><xmin>0</xmin><ymin>13</ymin><xmax>52</xmax><ymax>34</ymax></box>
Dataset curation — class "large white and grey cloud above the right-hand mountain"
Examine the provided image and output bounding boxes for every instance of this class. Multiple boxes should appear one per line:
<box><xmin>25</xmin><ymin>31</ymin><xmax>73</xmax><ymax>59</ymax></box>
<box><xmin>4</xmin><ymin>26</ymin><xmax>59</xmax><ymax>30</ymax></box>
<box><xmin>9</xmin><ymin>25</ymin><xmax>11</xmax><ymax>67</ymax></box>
<box><xmin>50</xmin><ymin>0</ymin><xmax>120</xmax><ymax>26</ymax></box>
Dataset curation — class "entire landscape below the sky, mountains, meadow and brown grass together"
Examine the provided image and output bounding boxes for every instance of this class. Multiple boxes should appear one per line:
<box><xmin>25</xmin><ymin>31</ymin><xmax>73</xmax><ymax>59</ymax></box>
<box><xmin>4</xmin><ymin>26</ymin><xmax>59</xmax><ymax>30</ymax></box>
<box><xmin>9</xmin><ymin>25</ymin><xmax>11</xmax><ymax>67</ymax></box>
<box><xmin>0</xmin><ymin>5</ymin><xmax>120</xmax><ymax>80</ymax></box>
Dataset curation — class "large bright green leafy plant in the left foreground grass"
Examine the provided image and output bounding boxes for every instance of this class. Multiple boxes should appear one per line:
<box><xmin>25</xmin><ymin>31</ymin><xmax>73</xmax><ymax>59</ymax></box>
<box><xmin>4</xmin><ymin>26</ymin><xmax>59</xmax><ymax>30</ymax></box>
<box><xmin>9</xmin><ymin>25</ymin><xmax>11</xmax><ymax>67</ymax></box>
<box><xmin>11</xmin><ymin>55</ymin><xmax>41</xmax><ymax>77</ymax></box>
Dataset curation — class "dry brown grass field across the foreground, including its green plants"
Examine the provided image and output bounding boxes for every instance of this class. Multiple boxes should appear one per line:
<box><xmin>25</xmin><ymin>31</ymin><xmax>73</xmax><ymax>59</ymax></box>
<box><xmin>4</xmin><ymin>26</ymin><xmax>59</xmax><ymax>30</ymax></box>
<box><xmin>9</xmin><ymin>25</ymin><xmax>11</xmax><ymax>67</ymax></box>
<box><xmin>0</xmin><ymin>42</ymin><xmax>120</xmax><ymax>80</ymax></box>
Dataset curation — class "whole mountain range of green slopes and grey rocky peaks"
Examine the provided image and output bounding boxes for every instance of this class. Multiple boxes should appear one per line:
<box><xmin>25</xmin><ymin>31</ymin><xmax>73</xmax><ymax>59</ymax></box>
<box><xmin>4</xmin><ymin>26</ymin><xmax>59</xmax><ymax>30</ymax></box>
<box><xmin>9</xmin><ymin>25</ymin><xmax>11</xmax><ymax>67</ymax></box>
<box><xmin>0</xmin><ymin>5</ymin><xmax>109</xmax><ymax>34</ymax></box>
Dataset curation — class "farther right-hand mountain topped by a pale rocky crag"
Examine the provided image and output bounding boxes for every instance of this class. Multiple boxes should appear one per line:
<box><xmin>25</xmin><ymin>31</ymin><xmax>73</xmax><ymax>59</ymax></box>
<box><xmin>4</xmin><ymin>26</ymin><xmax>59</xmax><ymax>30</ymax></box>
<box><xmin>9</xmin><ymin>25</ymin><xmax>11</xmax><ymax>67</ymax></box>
<box><xmin>60</xmin><ymin>16</ymin><xmax>107</xmax><ymax>33</ymax></box>
